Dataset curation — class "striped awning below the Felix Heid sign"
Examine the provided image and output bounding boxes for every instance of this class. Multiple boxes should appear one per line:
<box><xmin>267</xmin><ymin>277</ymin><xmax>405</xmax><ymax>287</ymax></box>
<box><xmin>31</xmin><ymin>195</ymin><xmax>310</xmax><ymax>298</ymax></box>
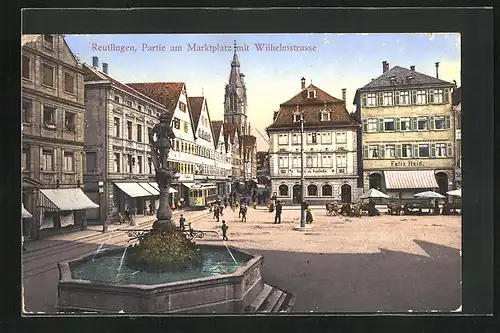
<box><xmin>384</xmin><ymin>170</ymin><xmax>439</xmax><ymax>189</ymax></box>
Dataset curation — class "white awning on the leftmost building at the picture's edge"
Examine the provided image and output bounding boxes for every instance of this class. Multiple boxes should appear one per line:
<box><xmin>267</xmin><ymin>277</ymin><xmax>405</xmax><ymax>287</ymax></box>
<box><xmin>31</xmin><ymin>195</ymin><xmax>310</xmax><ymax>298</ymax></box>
<box><xmin>40</xmin><ymin>188</ymin><xmax>99</xmax><ymax>210</ymax></box>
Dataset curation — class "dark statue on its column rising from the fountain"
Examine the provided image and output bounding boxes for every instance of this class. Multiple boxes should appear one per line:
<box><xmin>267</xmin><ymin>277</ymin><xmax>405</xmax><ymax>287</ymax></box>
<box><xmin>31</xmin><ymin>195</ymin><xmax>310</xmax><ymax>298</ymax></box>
<box><xmin>149</xmin><ymin>112</ymin><xmax>176</xmax><ymax>229</ymax></box>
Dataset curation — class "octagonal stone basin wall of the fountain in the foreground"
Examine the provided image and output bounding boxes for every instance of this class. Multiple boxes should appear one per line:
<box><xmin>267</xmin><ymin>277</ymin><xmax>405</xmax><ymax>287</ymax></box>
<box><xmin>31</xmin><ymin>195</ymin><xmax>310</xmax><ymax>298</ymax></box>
<box><xmin>57</xmin><ymin>245</ymin><xmax>264</xmax><ymax>313</ymax></box>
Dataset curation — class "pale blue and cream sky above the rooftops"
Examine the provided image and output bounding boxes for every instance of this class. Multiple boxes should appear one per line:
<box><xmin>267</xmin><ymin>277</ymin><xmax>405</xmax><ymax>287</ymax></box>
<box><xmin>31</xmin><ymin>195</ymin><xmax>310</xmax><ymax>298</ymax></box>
<box><xmin>66</xmin><ymin>33</ymin><xmax>460</xmax><ymax>150</ymax></box>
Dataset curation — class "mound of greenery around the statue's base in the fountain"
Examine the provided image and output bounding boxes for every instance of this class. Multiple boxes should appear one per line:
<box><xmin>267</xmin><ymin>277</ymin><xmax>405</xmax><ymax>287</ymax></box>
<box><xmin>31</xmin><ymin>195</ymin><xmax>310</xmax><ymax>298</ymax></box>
<box><xmin>127</xmin><ymin>230</ymin><xmax>201</xmax><ymax>272</ymax></box>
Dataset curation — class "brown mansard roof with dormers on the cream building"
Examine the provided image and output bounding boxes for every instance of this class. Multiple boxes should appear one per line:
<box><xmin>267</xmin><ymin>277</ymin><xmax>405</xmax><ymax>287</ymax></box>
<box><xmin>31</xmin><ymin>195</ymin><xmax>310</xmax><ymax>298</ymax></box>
<box><xmin>268</xmin><ymin>84</ymin><xmax>359</xmax><ymax>130</ymax></box>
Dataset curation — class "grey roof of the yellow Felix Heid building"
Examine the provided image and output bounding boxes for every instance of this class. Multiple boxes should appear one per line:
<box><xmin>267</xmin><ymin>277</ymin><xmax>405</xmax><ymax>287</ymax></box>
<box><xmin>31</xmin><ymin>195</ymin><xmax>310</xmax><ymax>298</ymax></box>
<box><xmin>360</xmin><ymin>66</ymin><xmax>454</xmax><ymax>91</ymax></box>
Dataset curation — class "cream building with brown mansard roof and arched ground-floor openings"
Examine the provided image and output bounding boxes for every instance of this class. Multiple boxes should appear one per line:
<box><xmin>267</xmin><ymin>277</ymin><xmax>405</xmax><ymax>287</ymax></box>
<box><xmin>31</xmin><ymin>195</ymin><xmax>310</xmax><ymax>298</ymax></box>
<box><xmin>267</xmin><ymin>78</ymin><xmax>360</xmax><ymax>204</ymax></box>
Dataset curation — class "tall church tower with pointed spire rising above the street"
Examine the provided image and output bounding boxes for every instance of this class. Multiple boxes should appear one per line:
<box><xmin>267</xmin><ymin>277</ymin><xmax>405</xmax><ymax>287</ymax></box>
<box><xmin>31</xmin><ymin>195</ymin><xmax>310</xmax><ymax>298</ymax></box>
<box><xmin>224</xmin><ymin>41</ymin><xmax>250</xmax><ymax>135</ymax></box>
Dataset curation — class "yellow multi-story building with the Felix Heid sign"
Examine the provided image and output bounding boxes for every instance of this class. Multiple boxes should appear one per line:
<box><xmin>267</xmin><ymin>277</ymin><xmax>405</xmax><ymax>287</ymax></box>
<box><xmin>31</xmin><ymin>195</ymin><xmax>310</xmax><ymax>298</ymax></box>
<box><xmin>354</xmin><ymin>61</ymin><xmax>455</xmax><ymax>198</ymax></box>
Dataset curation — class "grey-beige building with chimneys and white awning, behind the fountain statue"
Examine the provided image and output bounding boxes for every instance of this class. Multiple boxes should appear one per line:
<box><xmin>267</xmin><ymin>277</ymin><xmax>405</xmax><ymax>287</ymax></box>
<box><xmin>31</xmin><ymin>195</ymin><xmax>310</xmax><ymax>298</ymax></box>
<box><xmin>84</xmin><ymin>57</ymin><xmax>167</xmax><ymax>221</ymax></box>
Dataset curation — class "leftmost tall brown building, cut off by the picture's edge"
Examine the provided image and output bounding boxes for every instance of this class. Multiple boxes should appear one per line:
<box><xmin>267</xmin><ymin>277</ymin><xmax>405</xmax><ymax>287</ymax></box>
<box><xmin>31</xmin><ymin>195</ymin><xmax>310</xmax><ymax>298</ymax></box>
<box><xmin>21</xmin><ymin>34</ymin><xmax>96</xmax><ymax>238</ymax></box>
